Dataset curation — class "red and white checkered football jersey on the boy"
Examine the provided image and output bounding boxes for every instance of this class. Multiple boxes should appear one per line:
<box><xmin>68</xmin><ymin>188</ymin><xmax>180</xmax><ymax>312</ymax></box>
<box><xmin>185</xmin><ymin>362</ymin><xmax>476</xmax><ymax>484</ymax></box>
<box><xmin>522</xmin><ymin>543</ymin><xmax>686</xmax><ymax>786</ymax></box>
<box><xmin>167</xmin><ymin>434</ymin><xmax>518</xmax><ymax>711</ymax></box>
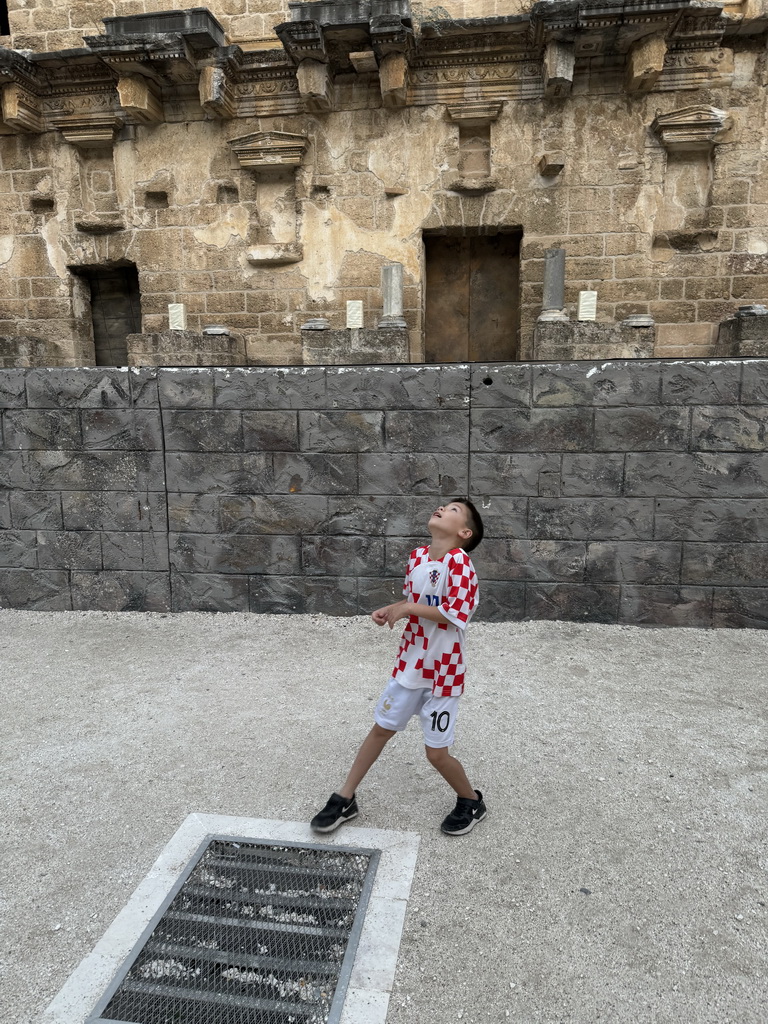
<box><xmin>392</xmin><ymin>546</ymin><xmax>478</xmax><ymax>697</ymax></box>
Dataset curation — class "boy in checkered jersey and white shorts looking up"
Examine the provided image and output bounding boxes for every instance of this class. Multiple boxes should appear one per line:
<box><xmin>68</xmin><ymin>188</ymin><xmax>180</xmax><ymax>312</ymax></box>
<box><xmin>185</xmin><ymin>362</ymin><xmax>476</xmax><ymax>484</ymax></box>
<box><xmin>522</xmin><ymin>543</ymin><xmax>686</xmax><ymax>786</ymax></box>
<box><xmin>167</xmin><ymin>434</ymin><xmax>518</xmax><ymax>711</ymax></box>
<box><xmin>310</xmin><ymin>498</ymin><xmax>486</xmax><ymax>836</ymax></box>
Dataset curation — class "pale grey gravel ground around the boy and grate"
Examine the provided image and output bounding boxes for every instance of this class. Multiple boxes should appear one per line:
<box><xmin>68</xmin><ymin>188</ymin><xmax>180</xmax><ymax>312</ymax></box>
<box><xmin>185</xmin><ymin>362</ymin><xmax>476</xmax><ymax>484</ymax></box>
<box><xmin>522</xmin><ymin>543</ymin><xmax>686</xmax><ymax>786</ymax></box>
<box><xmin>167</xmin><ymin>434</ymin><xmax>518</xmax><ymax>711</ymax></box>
<box><xmin>0</xmin><ymin>611</ymin><xmax>768</xmax><ymax>1024</ymax></box>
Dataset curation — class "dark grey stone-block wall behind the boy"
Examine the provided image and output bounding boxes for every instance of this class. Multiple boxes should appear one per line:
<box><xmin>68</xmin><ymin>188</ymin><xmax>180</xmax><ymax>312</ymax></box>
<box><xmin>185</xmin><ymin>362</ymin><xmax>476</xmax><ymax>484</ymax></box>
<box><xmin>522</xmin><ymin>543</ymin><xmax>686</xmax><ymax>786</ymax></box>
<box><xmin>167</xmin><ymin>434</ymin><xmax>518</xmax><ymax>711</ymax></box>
<box><xmin>0</xmin><ymin>359</ymin><xmax>768</xmax><ymax>627</ymax></box>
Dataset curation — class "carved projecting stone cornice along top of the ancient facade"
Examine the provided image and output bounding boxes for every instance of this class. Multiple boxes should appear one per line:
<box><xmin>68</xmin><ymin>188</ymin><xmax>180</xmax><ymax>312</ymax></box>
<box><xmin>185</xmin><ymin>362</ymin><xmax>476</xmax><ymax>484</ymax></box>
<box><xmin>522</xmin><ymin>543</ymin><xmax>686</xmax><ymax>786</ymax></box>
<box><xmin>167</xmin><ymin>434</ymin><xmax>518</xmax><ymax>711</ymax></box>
<box><xmin>0</xmin><ymin>0</ymin><xmax>768</xmax><ymax>137</ymax></box>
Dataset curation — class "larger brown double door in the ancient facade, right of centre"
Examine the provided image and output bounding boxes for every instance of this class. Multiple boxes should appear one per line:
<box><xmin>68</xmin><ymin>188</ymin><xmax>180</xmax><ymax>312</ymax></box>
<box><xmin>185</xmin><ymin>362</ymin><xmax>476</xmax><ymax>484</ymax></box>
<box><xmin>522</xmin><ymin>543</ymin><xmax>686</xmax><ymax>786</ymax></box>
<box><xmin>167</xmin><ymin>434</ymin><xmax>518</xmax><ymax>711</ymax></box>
<box><xmin>424</xmin><ymin>231</ymin><xmax>521</xmax><ymax>362</ymax></box>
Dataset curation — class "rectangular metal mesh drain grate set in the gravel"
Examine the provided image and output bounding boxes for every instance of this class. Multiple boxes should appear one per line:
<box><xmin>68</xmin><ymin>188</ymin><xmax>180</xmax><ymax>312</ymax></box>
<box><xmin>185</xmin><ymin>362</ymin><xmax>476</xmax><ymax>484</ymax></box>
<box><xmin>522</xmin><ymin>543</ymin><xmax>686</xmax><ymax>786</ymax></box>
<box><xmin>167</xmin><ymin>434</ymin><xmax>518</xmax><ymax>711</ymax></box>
<box><xmin>88</xmin><ymin>838</ymin><xmax>379</xmax><ymax>1024</ymax></box>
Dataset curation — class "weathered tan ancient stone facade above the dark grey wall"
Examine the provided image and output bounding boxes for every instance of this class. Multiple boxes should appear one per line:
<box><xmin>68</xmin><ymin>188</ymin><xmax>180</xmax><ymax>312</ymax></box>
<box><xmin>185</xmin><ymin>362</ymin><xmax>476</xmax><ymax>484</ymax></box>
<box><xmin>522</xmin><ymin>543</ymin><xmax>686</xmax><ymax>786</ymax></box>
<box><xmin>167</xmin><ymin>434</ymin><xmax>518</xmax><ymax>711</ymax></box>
<box><xmin>0</xmin><ymin>0</ymin><xmax>768</xmax><ymax>366</ymax></box>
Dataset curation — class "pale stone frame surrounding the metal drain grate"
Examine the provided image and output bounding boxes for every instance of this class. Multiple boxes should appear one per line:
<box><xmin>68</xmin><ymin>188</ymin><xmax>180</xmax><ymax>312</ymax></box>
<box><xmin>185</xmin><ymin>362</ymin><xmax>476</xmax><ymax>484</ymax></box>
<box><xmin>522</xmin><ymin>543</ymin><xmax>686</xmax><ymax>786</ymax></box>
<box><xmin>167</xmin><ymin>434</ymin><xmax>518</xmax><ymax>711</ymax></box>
<box><xmin>41</xmin><ymin>814</ymin><xmax>419</xmax><ymax>1024</ymax></box>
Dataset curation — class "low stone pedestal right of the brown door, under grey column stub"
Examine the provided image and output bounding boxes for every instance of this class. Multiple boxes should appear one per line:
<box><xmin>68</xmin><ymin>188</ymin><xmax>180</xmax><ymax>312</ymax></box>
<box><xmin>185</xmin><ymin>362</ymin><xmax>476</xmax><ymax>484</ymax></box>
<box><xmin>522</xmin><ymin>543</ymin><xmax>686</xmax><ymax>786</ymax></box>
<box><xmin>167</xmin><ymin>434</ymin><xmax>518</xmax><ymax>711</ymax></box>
<box><xmin>534</xmin><ymin>321</ymin><xmax>656</xmax><ymax>362</ymax></box>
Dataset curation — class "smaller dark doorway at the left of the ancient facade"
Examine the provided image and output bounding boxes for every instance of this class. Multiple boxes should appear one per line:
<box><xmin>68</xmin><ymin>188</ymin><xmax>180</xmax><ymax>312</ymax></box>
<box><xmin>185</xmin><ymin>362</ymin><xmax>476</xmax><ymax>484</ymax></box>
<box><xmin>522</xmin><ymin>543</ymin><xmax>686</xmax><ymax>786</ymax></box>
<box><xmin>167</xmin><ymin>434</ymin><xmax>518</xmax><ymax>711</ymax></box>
<box><xmin>72</xmin><ymin>263</ymin><xmax>141</xmax><ymax>367</ymax></box>
